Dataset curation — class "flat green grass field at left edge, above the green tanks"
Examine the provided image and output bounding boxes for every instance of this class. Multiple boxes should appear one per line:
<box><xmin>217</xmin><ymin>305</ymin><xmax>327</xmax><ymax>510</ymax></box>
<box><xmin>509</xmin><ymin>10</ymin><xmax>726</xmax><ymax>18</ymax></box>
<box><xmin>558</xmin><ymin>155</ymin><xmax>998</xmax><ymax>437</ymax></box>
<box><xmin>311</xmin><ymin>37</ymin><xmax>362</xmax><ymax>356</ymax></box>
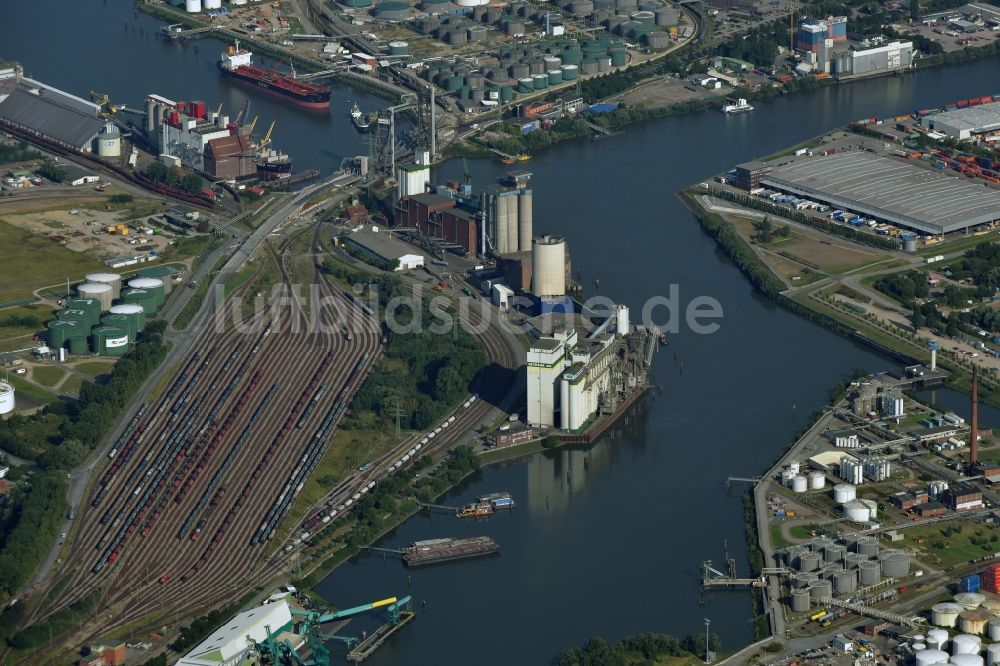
<box><xmin>0</xmin><ymin>220</ymin><xmax>107</xmax><ymax>302</ymax></box>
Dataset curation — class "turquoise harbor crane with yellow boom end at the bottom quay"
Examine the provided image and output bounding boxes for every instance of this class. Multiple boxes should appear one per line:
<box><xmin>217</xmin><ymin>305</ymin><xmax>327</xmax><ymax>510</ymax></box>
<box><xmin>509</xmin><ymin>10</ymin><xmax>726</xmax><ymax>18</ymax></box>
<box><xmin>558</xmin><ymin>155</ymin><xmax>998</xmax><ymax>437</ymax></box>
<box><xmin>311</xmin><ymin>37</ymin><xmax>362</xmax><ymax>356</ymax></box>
<box><xmin>254</xmin><ymin>596</ymin><xmax>414</xmax><ymax>666</ymax></box>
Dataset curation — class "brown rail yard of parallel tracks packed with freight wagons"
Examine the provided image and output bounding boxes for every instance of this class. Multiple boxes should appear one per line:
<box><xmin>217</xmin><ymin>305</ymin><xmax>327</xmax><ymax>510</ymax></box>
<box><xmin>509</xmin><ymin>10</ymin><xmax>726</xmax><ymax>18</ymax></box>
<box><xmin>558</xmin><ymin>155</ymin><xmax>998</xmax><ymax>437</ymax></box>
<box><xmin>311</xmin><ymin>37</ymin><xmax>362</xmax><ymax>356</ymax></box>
<box><xmin>19</xmin><ymin>224</ymin><xmax>517</xmax><ymax>639</ymax></box>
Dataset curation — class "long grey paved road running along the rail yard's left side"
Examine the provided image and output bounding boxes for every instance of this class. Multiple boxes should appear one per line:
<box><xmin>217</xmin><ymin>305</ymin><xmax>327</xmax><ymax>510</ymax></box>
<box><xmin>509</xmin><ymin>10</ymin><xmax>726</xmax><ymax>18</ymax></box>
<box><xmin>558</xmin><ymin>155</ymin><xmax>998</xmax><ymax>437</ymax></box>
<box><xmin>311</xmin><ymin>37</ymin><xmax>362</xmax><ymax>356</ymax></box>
<box><xmin>26</xmin><ymin>177</ymin><xmax>352</xmax><ymax>590</ymax></box>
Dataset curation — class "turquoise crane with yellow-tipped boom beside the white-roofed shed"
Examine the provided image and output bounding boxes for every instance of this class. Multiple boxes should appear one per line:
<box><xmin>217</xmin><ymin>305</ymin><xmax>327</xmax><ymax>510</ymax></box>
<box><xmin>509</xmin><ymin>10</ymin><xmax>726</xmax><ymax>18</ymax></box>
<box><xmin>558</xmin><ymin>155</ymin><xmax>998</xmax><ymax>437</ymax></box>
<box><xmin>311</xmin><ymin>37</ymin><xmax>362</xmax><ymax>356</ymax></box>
<box><xmin>255</xmin><ymin>596</ymin><xmax>412</xmax><ymax>666</ymax></box>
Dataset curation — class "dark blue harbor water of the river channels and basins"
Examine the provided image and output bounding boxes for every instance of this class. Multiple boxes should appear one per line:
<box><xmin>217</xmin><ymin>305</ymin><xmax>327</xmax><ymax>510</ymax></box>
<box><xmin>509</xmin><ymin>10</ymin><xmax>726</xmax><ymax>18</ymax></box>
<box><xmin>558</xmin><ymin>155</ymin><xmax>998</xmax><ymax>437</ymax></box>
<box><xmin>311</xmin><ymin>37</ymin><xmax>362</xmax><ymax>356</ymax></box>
<box><xmin>0</xmin><ymin>0</ymin><xmax>996</xmax><ymax>666</ymax></box>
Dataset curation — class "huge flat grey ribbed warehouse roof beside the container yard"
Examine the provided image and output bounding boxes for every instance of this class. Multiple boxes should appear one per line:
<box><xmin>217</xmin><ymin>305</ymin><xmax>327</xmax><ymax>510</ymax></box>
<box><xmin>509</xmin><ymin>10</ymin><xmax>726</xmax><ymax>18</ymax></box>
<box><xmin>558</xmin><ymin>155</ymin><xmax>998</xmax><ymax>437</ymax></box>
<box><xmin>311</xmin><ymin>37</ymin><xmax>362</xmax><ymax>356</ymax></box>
<box><xmin>762</xmin><ymin>151</ymin><xmax>1000</xmax><ymax>234</ymax></box>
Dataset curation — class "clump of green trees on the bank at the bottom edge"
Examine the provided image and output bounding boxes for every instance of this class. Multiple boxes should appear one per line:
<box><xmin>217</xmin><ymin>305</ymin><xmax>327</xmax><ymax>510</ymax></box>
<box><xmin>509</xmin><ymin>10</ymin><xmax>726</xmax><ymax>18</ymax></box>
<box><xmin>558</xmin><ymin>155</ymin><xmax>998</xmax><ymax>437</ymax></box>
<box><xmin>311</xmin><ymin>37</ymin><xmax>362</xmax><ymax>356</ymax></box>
<box><xmin>558</xmin><ymin>633</ymin><xmax>721</xmax><ymax>666</ymax></box>
